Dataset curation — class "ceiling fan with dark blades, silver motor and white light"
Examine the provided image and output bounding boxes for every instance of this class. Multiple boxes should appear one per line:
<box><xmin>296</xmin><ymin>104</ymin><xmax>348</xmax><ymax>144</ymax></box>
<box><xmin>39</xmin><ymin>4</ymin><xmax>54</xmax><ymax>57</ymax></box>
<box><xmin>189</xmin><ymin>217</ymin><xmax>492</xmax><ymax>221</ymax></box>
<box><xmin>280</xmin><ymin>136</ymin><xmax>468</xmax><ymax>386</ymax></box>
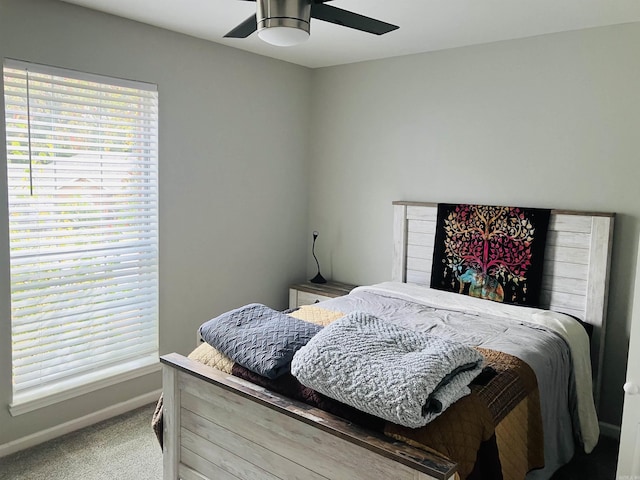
<box><xmin>225</xmin><ymin>0</ymin><xmax>398</xmax><ymax>47</ymax></box>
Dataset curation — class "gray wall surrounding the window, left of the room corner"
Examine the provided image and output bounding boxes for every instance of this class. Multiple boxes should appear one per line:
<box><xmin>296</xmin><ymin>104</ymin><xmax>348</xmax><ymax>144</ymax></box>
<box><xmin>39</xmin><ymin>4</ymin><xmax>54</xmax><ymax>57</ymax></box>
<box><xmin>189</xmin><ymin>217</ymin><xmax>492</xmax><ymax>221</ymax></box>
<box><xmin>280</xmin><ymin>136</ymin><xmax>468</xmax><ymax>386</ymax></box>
<box><xmin>0</xmin><ymin>0</ymin><xmax>311</xmax><ymax>445</ymax></box>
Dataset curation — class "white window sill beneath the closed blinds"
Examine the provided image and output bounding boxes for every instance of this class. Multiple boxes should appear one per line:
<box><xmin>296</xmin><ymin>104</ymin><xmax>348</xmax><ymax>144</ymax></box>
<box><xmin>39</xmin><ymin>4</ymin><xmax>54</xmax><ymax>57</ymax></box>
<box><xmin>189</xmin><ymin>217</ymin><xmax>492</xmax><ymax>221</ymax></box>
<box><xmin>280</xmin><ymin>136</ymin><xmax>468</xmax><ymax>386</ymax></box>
<box><xmin>9</xmin><ymin>356</ymin><xmax>161</xmax><ymax>417</ymax></box>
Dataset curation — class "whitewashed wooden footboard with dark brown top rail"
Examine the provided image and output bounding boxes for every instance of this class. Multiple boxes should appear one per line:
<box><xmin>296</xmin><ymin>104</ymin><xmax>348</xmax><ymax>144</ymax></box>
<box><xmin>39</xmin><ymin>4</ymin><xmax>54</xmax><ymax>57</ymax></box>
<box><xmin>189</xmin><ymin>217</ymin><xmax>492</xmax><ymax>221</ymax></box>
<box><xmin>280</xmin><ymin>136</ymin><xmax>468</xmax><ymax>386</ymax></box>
<box><xmin>161</xmin><ymin>353</ymin><xmax>456</xmax><ymax>480</ymax></box>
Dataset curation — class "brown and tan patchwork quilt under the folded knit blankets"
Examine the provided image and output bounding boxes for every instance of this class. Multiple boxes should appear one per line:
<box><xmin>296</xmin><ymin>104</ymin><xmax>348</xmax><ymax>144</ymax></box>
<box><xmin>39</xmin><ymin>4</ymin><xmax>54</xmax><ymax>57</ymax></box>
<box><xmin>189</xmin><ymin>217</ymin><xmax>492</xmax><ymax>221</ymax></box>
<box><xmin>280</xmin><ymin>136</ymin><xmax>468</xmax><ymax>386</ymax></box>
<box><xmin>152</xmin><ymin>306</ymin><xmax>544</xmax><ymax>480</ymax></box>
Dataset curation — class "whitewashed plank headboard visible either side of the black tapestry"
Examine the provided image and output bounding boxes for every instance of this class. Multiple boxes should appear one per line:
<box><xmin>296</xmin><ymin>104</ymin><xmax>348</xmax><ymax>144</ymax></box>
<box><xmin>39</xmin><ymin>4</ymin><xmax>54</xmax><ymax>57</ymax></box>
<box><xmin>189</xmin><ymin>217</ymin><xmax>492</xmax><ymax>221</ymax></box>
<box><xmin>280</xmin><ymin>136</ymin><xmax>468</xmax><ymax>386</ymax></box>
<box><xmin>392</xmin><ymin>201</ymin><xmax>615</xmax><ymax>407</ymax></box>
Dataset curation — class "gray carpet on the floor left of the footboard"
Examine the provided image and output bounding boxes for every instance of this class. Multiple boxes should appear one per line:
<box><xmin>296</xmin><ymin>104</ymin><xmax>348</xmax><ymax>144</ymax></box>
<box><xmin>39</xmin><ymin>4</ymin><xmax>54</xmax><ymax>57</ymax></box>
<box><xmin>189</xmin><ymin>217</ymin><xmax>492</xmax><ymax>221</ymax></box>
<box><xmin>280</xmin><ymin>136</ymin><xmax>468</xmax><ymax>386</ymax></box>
<box><xmin>0</xmin><ymin>405</ymin><xmax>162</xmax><ymax>480</ymax></box>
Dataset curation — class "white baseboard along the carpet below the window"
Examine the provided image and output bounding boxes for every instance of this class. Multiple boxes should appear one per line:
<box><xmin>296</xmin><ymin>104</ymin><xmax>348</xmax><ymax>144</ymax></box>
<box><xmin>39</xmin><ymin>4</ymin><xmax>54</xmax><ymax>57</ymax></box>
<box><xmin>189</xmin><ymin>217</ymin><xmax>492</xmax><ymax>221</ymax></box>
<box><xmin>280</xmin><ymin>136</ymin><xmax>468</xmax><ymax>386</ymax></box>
<box><xmin>0</xmin><ymin>389</ymin><xmax>162</xmax><ymax>458</ymax></box>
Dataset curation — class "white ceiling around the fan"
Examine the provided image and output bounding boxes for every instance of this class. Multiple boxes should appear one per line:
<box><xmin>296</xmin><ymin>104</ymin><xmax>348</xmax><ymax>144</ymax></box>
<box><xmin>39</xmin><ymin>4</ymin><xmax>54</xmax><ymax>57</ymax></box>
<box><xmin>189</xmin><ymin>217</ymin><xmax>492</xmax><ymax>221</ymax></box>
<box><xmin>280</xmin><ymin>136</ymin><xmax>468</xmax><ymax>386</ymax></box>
<box><xmin>58</xmin><ymin>0</ymin><xmax>640</xmax><ymax>68</ymax></box>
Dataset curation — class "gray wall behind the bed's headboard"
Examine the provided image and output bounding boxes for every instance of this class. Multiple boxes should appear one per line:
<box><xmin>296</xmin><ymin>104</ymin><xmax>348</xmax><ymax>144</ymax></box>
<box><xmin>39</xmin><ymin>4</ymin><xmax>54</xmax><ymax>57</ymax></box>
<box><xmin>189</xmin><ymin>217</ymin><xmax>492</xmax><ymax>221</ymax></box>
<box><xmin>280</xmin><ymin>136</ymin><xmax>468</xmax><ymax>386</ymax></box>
<box><xmin>308</xmin><ymin>23</ymin><xmax>640</xmax><ymax>425</ymax></box>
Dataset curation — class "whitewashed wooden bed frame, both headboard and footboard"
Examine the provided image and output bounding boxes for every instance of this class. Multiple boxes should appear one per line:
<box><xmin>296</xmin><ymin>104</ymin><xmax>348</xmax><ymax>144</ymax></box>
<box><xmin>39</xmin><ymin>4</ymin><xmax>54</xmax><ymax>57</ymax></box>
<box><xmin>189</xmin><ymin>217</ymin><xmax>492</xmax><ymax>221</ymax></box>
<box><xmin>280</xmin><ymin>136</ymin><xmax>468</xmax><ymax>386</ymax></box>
<box><xmin>160</xmin><ymin>202</ymin><xmax>614</xmax><ymax>480</ymax></box>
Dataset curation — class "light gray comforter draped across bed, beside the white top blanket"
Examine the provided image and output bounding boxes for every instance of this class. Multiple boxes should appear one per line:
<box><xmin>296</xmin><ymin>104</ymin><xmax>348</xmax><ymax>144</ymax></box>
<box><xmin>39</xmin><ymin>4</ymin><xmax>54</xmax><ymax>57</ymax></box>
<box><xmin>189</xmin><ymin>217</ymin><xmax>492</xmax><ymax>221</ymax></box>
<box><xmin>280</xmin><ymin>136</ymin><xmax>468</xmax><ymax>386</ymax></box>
<box><xmin>321</xmin><ymin>284</ymin><xmax>580</xmax><ymax>480</ymax></box>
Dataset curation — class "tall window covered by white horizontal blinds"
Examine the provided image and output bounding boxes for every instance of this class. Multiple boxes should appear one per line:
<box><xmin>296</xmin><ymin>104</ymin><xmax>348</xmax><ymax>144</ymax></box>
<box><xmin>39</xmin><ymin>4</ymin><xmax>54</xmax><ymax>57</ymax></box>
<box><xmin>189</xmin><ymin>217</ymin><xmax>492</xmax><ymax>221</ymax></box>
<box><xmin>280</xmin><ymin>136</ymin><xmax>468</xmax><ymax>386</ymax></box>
<box><xmin>4</xmin><ymin>60</ymin><xmax>158</xmax><ymax>415</ymax></box>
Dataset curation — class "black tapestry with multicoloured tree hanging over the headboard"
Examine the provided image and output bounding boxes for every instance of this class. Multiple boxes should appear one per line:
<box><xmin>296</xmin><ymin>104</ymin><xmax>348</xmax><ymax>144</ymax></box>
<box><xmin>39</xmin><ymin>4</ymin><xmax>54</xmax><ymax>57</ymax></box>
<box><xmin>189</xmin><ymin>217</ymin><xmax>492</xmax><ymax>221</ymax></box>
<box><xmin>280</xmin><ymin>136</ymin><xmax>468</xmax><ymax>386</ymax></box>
<box><xmin>431</xmin><ymin>203</ymin><xmax>551</xmax><ymax>306</ymax></box>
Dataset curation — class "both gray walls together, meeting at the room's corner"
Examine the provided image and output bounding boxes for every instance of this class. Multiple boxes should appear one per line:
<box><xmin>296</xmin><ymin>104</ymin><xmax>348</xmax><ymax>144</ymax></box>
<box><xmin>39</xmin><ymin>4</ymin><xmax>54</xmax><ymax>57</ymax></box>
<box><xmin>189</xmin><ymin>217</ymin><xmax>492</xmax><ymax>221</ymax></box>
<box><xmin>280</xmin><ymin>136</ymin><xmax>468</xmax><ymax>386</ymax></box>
<box><xmin>0</xmin><ymin>0</ymin><xmax>640</xmax><ymax>478</ymax></box>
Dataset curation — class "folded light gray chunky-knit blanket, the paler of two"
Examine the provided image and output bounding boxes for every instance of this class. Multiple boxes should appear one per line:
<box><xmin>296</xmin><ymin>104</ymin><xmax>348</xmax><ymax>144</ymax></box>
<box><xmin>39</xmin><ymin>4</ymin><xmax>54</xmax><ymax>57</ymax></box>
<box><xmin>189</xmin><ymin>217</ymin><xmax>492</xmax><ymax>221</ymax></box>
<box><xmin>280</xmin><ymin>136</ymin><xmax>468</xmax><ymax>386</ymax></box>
<box><xmin>291</xmin><ymin>312</ymin><xmax>484</xmax><ymax>428</ymax></box>
